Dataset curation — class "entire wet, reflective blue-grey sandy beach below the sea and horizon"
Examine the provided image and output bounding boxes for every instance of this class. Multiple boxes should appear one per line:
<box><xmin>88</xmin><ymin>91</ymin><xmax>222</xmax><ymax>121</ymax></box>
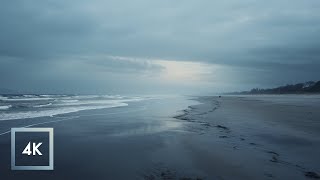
<box><xmin>0</xmin><ymin>95</ymin><xmax>320</xmax><ymax>180</ymax></box>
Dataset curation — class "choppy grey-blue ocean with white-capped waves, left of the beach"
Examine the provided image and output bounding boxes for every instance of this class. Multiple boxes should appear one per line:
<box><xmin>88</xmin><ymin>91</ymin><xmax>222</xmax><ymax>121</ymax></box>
<box><xmin>0</xmin><ymin>95</ymin><xmax>151</xmax><ymax>121</ymax></box>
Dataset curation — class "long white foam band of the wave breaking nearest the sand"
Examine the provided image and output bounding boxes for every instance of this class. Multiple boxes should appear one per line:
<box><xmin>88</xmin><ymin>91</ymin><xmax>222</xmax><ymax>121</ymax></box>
<box><xmin>0</xmin><ymin>103</ymin><xmax>128</xmax><ymax>121</ymax></box>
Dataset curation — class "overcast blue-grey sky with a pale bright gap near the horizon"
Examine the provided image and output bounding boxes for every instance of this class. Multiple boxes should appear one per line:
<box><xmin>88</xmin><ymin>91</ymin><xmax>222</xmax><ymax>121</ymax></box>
<box><xmin>0</xmin><ymin>0</ymin><xmax>320</xmax><ymax>94</ymax></box>
